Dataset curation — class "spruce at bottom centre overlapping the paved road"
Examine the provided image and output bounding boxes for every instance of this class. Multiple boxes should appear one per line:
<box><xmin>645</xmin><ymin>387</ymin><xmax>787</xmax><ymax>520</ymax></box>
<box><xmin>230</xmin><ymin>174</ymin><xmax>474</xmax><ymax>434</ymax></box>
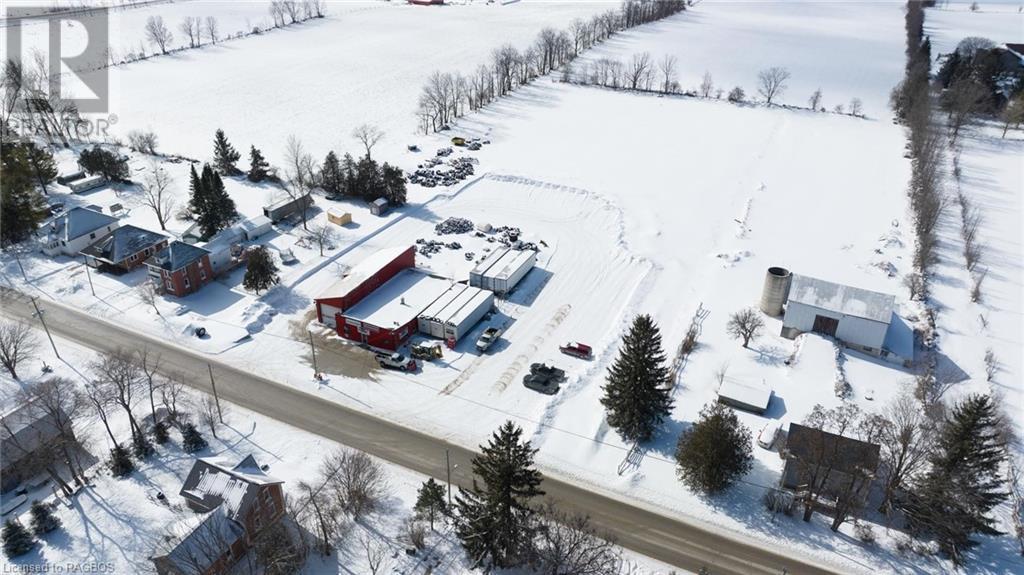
<box><xmin>456</xmin><ymin>422</ymin><xmax>544</xmax><ymax>568</ymax></box>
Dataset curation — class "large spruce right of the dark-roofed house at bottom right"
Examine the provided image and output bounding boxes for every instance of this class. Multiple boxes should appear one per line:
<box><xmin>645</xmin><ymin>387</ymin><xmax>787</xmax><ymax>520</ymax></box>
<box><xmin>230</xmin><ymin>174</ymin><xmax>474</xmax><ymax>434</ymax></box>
<box><xmin>904</xmin><ymin>395</ymin><xmax>1009</xmax><ymax>566</ymax></box>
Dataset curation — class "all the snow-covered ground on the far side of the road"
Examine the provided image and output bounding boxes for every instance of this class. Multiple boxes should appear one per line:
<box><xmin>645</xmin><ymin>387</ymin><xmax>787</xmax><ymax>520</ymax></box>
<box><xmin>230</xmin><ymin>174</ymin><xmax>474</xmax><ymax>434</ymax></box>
<box><xmin>3</xmin><ymin>2</ymin><xmax>1024</xmax><ymax>573</ymax></box>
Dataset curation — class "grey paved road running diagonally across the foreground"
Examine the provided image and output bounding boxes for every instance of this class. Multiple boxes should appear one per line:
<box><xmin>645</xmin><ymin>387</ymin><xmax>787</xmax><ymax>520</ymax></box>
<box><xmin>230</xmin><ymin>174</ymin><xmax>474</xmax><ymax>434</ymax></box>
<box><xmin>0</xmin><ymin>288</ymin><xmax>838</xmax><ymax>575</ymax></box>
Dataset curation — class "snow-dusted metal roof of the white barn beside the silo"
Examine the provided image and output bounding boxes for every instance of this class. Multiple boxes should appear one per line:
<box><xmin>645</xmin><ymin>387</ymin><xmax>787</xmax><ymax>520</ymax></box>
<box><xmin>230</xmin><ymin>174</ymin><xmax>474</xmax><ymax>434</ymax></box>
<box><xmin>788</xmin><ymin>274</ymin><xmax>896</xmax><ymax>323</ymax></box>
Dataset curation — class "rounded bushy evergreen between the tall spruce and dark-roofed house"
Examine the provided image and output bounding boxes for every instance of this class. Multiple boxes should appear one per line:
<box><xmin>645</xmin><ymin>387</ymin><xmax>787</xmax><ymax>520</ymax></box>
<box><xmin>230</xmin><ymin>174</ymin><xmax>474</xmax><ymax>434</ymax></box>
<box><xmin>676</xmin><ymin>402</ymin><xmax>754</xmax><ymax>494</ymax></box>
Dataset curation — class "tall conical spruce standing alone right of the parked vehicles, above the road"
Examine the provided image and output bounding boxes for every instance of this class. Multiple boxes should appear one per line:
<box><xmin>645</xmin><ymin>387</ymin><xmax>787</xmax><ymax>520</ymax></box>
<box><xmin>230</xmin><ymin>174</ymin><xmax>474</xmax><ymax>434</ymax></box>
<box><xmin>601</xmin><ymin>315</ymin><xmax>672</xmax><ymax>441</ymax></box>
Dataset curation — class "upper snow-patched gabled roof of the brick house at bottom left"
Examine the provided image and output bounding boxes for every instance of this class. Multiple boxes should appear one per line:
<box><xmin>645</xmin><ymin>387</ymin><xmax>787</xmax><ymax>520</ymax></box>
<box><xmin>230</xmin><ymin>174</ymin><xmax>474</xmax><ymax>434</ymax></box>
<box><xmin>180</xmin><ymin>455</ymin><xmax>283</xmax><ymax>519</ymax></box>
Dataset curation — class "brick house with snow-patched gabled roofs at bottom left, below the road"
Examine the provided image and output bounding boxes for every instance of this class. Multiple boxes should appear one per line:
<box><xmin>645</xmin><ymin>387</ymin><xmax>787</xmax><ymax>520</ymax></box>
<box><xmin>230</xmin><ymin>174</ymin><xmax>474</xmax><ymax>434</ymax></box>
<box><xmin>153</xmin><ymin>455</ymin><xmax>285</xmax><ymax>575</ymax></box>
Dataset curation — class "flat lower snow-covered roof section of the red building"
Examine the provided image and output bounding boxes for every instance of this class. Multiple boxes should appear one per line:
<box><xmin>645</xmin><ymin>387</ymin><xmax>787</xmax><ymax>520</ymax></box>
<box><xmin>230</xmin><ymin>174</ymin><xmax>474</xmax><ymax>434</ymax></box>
<box><xmin>343</xmin><ymin>269</ymin><xmax>452</xmax><ymax>329</ymax></box>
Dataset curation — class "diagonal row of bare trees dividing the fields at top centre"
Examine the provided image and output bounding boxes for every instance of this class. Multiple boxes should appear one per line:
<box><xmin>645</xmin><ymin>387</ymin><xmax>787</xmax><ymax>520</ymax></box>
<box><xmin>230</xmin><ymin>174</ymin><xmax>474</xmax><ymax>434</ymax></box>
<box><xmin>417</xmin><ymin>0</ymin><xmax>686</xmax><ymax>134</ymax></box>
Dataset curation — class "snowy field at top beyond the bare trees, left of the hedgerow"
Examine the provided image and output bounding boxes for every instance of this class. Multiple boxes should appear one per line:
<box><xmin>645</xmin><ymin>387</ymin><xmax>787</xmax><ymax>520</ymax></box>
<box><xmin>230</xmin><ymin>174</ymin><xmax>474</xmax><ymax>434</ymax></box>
<box><xmin>573</xmin><ymin>0</ymin><xmax>903</xmax><ymax>119</ymax></box>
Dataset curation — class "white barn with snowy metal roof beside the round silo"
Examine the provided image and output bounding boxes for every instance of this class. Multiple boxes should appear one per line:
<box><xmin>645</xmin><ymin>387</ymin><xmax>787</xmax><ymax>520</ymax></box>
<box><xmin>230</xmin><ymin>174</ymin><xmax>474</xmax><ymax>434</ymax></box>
<box><xmin>782</xmin><ymin>274</ymin><xmax>913</xmax><ymax>364</ymax></box>
